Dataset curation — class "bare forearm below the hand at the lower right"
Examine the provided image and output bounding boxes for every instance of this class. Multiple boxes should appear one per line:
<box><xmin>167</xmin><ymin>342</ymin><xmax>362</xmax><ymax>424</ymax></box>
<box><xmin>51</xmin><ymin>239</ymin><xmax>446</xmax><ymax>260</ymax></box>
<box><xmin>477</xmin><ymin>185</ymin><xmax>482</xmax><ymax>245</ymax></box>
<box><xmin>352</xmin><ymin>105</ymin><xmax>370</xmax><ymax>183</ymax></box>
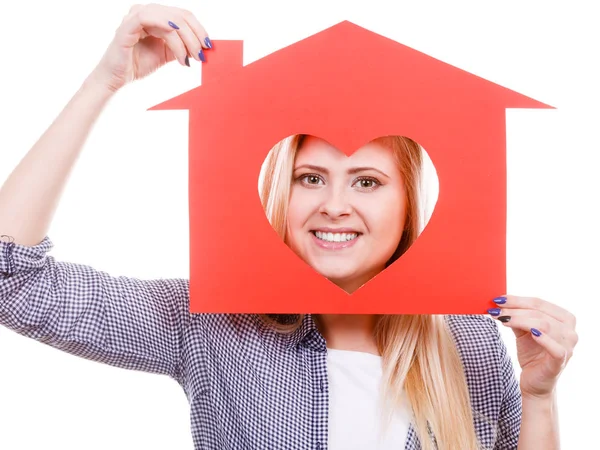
<box><xmin>518</xmin><ymin>393</ymin><xmax>560</xmax><ymax>450</ymax></box>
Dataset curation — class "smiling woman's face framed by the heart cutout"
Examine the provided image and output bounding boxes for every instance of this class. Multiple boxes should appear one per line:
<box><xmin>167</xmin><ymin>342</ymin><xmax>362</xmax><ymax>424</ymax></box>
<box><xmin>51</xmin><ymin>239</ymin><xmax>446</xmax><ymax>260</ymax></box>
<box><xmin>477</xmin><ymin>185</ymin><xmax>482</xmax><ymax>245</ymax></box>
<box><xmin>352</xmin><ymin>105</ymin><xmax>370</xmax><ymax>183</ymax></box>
<box><xmin>286</xmin><ymin>136</ymin><xmax>406</xmax><ymax>292</ymax></box>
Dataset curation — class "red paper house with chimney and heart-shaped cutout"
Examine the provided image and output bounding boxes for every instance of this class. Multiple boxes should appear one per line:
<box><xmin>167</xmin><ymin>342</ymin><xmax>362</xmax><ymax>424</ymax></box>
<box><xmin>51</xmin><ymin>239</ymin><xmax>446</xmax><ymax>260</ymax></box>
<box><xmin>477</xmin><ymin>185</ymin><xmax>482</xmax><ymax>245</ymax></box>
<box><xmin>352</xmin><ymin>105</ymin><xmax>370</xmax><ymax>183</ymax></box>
<box><xmin>151</xmin><ymin>22</ymin><xmax>549</xmax><ymax>314</ymax></box>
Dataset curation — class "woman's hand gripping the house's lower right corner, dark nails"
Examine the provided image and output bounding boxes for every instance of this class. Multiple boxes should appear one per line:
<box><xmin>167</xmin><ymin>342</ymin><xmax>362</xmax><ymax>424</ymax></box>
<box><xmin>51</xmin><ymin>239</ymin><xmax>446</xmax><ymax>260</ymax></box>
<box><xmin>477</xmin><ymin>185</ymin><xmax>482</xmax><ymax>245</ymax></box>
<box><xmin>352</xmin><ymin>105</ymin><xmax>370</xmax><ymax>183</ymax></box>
<box><xmin>488</xmin><ymin>295</ymin><xmax>578</xmax><ymax>398</ymax></box>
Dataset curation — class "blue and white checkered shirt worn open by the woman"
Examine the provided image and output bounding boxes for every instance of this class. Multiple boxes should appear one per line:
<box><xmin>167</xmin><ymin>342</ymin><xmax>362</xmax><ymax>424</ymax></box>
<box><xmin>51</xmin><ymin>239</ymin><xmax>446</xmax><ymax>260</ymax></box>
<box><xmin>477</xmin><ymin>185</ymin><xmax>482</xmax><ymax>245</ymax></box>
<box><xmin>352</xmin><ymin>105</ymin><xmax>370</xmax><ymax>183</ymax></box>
<box><xmin>0</xmin><ymin>237</ymin><xmax>521</xmax><ymax>450</ymax></box>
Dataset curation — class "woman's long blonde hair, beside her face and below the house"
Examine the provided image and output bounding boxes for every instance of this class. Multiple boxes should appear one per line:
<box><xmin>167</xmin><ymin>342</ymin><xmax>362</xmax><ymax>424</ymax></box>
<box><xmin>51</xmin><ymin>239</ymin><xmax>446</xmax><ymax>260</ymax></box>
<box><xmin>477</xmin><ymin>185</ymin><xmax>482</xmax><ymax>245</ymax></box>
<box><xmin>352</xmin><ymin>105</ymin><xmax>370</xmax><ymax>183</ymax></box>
<box><xmin>259</xmin><ymin>135</ymin><xmax>479</xmax><ymax>450</ymax></box>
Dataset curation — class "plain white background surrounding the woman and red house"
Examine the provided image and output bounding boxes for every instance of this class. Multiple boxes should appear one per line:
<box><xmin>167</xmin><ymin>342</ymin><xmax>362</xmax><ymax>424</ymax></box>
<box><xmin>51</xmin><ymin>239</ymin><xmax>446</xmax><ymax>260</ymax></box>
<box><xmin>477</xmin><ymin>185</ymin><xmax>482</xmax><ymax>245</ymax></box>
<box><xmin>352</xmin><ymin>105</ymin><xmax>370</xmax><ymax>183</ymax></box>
<box><xmin>0</xmin><ymin>0</ymin><xmax>600</xmax><ymax>450</ymax></box>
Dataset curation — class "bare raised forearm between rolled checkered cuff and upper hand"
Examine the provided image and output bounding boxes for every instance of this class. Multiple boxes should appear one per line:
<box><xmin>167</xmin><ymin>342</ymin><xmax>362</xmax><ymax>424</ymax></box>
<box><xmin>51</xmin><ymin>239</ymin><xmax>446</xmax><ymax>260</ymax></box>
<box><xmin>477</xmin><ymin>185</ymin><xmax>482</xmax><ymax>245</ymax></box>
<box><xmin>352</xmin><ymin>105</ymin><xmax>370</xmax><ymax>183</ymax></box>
<box><xmin>0</xmin><ymin>78</ymin><xmax>113</xmax><ymax>246</ymax></box>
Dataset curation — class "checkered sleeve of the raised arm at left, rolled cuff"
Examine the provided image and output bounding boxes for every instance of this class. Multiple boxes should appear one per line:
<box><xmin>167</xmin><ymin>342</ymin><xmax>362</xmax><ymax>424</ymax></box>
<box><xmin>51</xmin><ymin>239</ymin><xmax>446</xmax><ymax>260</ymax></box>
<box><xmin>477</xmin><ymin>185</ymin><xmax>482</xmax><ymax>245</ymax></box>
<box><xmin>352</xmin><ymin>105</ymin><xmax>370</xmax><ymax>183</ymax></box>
<box><xmin>0</xmin><ymin>236</ymin><xmax>189</xmax><ymax>380</ymax></box>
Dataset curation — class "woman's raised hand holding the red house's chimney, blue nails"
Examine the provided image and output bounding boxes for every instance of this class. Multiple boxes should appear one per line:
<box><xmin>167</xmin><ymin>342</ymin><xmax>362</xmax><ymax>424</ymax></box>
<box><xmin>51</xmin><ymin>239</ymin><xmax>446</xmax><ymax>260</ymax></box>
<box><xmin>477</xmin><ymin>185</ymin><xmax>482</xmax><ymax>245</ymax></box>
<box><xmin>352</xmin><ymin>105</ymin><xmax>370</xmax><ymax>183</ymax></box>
<box><xmin>90</xmin><ymin>4</ymin><xmax>212</xmax><ymax>92</ymax></box>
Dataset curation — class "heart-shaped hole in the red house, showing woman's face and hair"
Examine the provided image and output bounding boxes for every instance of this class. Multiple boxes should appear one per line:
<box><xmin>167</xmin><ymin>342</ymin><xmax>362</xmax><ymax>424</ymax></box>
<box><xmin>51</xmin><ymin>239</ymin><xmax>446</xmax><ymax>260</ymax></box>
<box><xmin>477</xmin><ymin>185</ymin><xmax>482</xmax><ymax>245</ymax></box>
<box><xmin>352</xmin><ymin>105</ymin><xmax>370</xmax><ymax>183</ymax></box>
<box><xmin>258</xmin><ymin>135</ymin><xmax>439</xmax><ymax>293</ymax></box>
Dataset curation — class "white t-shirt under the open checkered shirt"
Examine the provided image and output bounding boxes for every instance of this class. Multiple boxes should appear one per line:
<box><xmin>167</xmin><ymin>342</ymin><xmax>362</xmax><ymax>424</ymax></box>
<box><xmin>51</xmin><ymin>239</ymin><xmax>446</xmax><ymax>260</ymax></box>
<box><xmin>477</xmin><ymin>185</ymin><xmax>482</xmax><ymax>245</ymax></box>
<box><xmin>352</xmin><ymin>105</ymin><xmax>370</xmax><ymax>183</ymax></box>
<box><xmin>327</xmin><ymin>348</ymin><xmax>410</xmax><ymax>450</ymax></box>
